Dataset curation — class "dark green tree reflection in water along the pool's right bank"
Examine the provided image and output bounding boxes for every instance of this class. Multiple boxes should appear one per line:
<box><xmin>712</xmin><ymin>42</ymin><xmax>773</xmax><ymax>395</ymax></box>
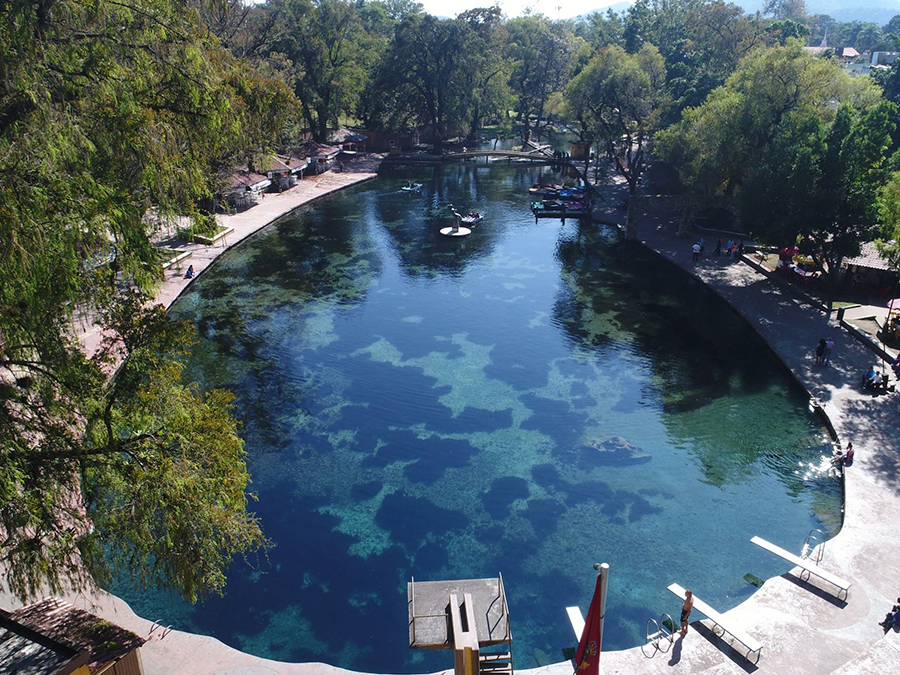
<box><xmin>553</xmin><ymin>223</ymin><xmax>828</xmax><ymax>492</ymax></box>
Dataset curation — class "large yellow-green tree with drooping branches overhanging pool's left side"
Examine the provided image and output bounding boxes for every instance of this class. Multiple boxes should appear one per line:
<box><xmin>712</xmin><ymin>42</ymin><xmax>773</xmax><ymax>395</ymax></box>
<box><xmin>0</xmin><ymin>0</ymin><xmax>291</xmax><ymax>598</ymax></box>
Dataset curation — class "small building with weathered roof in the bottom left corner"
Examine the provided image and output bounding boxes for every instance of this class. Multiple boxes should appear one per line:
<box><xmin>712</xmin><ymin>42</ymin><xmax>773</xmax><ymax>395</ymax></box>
<box><xmin>0</xmin><ymin>598</ymin><xmax>146</xmax><ymax>675</ymax></box>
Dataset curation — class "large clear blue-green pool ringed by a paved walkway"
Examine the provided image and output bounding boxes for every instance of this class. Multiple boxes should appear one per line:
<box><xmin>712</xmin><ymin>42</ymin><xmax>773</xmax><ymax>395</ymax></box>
<box><xmin>113</xmin><ymin>164</ymin><xmax>841</xmax><ymax>673</ymax></box>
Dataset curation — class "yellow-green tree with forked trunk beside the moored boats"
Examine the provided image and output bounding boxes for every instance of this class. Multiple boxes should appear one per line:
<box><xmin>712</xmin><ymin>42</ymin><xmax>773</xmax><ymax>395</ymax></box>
<box><xmin>566</xmin><ymin>44</ymin><xmax>666</xmax><ymax>194</ymax></box>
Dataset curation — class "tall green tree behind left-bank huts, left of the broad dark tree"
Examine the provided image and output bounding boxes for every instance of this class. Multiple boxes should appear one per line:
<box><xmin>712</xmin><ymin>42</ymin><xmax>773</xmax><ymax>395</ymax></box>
<box><xmin>270</xmin><ymin>0</ymin><xmax>370</xmax><ymax>142</ymax></box>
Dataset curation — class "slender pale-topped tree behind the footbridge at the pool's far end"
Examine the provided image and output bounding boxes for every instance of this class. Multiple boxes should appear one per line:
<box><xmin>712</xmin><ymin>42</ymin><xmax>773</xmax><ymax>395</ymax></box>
<box><xmin>506</xmin><ymin>16</ymin><xmax>574</xmax><ymax>141</ymax></box>
